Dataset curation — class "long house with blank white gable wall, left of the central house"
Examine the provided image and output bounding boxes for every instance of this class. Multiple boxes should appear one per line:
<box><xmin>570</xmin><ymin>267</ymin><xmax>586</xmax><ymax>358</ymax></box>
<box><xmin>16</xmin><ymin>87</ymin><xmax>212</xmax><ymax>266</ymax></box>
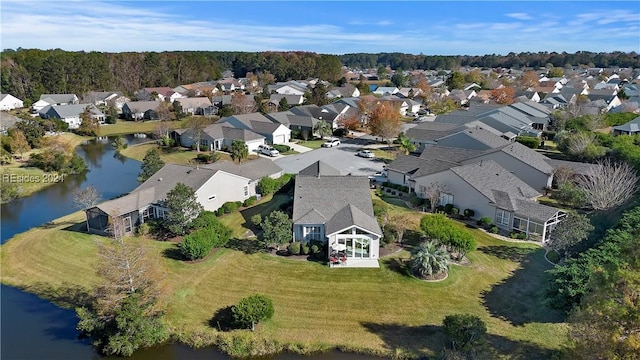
<box><xmin>86</xmin><ymin>158</ymin><xmax>282</xmax><ymax>234</ymax></box>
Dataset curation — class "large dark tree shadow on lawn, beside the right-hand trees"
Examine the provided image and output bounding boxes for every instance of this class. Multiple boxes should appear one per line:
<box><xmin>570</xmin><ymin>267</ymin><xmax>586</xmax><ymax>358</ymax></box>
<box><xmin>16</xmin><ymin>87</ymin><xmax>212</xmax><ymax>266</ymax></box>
<box><xmin>478</xmin><ymin>246</ymin><xmax>564</xmax><ymax>326</ymax></box>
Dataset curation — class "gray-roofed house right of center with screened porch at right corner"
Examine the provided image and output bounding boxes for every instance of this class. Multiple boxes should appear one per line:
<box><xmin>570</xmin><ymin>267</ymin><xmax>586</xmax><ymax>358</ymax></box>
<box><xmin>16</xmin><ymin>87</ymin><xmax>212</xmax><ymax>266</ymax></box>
<box><xmin>387</xmin><ymin>156</ymin><xmax>565</xmax><ymax>243</ymax></box>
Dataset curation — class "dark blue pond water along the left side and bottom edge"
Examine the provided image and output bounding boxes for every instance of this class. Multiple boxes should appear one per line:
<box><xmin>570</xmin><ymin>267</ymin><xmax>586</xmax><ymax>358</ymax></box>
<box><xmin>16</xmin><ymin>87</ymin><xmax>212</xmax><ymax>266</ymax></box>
<box><xmin>0</xmin><ymin>136</ymin><xmax>380</xmax><ymax>360</ymax></box>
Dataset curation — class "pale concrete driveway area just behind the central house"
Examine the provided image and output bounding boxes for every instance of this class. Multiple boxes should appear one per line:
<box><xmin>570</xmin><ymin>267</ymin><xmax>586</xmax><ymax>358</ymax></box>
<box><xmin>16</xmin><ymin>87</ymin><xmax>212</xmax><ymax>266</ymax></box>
<box><xmin>274</xmin><ymin>139</ymin><xmax>384</xmax><ymax>176</ymax></box>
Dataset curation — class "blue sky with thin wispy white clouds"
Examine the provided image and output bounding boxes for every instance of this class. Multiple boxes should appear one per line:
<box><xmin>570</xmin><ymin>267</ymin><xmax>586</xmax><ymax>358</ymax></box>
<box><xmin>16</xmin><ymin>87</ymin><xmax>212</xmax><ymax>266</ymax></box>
<box><xmin>0</xmin><ymin>0</ymin><xmax>640</xmax><ymax>55</ymax></box>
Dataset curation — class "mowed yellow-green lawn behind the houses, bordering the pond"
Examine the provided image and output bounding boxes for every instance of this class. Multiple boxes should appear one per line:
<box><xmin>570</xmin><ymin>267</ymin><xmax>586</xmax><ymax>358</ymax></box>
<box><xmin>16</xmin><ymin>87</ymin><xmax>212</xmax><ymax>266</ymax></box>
<box><xmin>0</xmin><ymin>201</ymin><xmax>566</xmax><ymax>359</ymax></box>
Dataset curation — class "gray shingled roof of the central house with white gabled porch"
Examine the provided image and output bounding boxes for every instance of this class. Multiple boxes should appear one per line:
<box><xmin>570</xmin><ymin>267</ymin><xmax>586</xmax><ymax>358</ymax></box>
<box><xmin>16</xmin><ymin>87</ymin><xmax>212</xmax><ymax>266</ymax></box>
<box><xmin>293</xmin><ymin>176</ymin><xmax>382</xmax><ymax>236</ymax></box>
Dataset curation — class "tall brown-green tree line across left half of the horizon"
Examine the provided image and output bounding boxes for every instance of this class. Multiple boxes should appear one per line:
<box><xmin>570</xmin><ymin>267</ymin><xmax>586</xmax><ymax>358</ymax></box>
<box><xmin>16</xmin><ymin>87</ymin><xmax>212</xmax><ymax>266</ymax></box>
<box><xmin>0</xmin><ymin>49</ymin><xmax>342</xmax><ymax>101</ymax></box>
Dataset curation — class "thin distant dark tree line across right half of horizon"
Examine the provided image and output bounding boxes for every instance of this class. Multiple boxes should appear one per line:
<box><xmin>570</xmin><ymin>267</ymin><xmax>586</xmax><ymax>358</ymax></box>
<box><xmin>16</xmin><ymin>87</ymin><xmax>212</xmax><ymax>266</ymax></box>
<box><xmin>340</xmin><ymin>51</ymin><xmax>640</xmax><ymax>70</ymax></box>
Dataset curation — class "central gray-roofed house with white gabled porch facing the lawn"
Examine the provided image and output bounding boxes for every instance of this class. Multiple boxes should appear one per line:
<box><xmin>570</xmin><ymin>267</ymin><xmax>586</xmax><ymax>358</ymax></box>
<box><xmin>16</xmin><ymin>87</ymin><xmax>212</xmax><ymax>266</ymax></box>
<box><xmin>293</xmin><ymin>165</ymin><xmax>382</xmax><ymax>268</ymax></box>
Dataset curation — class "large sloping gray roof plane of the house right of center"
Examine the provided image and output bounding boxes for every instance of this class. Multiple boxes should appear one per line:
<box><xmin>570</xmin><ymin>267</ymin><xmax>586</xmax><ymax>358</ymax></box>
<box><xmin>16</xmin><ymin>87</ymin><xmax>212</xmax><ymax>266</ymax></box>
<box><xmin>451</xmin><ymin>160</ymin><xmax>540</xmax><ymax>203</ymax></box>
